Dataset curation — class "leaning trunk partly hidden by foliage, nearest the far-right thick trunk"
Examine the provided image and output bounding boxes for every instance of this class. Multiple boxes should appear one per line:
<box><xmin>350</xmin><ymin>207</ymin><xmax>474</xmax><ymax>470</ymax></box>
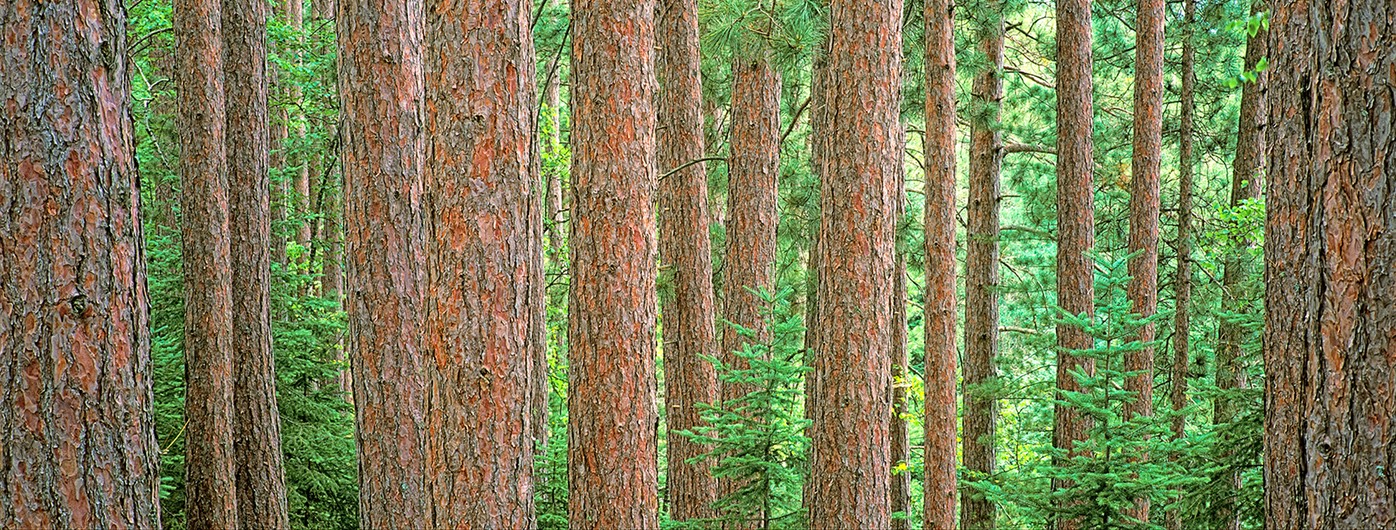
<box><xmin>1213</xmin><ymin>1</ymin><xmax>1270</xmax><ymax>530</ymax></box>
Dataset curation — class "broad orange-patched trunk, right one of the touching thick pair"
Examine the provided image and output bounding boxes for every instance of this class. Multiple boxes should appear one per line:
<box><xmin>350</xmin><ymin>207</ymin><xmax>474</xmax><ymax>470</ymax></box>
<box><xmin>423</xmin><ymin>0</ymin><xmax>544</xmax><ymax>530</ymax></box>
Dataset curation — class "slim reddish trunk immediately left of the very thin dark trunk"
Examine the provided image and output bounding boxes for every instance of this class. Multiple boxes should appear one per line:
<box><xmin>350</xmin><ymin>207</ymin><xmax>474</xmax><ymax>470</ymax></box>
<box><xmin>1124</xmin><ymin>0</ymin><xmax>1164</xmax><ymax>523</ymax></box>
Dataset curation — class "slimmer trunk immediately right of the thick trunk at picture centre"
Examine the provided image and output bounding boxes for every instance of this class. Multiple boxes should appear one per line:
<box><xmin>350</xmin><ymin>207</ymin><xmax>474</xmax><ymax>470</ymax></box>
<box><xmin>656</xmin><ymin>0</ymin><xmax>718</xmax><ymax>520</ymax></box>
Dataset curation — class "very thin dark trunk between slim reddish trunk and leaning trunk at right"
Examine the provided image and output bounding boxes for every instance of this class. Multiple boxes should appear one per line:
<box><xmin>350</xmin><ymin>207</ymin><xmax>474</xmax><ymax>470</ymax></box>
<box><xmin>1166</xmin><ymin>0</ymin><xmax>1198</xmax><ymax>530</ymax></box>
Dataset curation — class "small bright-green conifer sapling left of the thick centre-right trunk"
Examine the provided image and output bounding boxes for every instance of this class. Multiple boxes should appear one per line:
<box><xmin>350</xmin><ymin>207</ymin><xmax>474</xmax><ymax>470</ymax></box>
<box><xmin>680</xmin><ymin>287</ymin><xmax>810</xmax><ymax>529</ymax></box>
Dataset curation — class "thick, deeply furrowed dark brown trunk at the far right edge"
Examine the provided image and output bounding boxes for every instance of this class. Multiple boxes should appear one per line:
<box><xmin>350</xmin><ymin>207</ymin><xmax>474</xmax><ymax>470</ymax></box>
<box><xmin>1265</xmin><ymin>0</ymin><xmax>1396</xmax><ymax>530</ymax></box>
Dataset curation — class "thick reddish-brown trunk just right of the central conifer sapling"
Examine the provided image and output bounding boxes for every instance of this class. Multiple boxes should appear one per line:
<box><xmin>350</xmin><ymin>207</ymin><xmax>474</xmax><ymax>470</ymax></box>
<box><xmin>805</xmin><ymin>0</ymin><xmax>903</xmax><ymax>530</ymax></box>
